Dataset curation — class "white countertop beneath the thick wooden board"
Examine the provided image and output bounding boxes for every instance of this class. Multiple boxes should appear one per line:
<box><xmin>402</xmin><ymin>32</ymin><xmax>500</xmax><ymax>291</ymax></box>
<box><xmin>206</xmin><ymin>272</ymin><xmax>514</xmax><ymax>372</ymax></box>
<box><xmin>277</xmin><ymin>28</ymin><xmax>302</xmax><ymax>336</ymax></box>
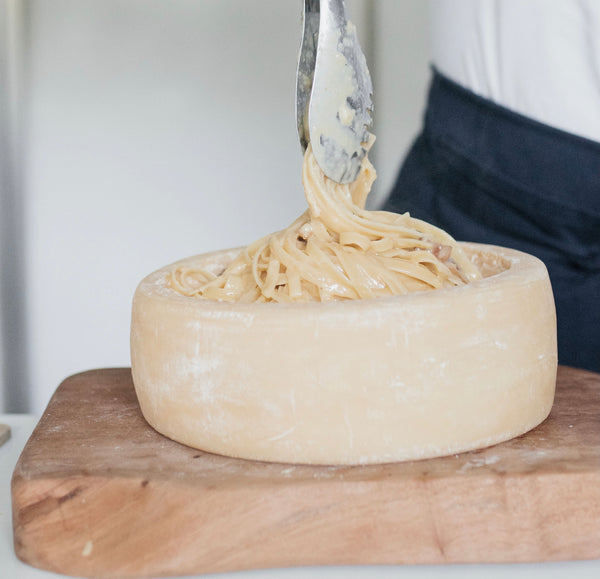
<box><xmin>0</xmin><ymin>414</ymin><xmax>600</xmax><ymax>579</ymax></box>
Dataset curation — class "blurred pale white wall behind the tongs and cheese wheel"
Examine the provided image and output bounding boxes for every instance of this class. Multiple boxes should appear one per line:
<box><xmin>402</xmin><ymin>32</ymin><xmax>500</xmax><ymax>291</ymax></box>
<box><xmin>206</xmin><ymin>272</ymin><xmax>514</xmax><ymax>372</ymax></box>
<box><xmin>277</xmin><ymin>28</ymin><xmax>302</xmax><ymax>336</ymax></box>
<box><xmin>0</xmin><ymin>0</ymin><xmax>429</xmax><ymax>413</ymax></box>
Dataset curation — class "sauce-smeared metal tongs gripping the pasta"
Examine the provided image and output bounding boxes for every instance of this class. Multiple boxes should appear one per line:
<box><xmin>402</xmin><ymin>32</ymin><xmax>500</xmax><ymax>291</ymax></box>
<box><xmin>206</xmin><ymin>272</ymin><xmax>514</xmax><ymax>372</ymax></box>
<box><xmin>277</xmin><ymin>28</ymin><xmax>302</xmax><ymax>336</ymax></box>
<box><xmin>296</xmin><ymin>0</ymin><xmax>373</xmax><ymax>183</ymax></box>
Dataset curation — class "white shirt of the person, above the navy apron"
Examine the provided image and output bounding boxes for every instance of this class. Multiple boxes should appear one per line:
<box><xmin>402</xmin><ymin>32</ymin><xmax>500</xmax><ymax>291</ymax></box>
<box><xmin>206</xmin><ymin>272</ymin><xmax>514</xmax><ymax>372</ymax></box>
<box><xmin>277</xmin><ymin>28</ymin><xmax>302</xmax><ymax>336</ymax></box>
<box><xmin>431</xmin><ymin>0</ymin><xmax>600</xmax><ymax>142</ymax></box>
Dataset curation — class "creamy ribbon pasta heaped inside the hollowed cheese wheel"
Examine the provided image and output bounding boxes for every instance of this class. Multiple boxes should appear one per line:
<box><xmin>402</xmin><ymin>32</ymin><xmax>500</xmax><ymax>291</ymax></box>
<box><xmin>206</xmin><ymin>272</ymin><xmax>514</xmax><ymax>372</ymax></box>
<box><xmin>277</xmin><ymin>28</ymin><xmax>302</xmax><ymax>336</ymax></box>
<box><xmin>171</xmin><ymin>146</ymin><xmax>481</xmax><ymax>302</ymax></box>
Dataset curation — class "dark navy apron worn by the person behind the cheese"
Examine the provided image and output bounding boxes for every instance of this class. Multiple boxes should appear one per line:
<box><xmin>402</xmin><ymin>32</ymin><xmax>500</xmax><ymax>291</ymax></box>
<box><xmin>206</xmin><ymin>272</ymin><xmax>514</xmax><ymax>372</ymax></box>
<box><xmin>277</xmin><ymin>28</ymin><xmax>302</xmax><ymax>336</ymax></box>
<box><xmin>385</xmin><ymin>70</ymin><xmax>600</xmax><ymax>372</ymax></box>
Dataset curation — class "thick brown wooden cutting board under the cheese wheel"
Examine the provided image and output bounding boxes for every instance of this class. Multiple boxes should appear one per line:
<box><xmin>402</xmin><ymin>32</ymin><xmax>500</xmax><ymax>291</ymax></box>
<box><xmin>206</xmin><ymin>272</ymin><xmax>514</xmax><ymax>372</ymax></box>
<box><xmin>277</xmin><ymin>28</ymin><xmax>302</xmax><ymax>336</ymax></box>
<box><xmin>12</xmin><ymin>368</ymin><xmax>600</xmax><ymax>577</ymax></box>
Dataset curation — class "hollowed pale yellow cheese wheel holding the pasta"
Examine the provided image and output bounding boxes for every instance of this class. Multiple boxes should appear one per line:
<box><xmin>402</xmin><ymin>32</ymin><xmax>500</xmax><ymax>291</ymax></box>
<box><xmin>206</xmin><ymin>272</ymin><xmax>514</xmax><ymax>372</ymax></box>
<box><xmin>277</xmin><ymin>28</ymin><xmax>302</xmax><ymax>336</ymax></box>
<box><xmin>131</xmin><ymin>244</ymin><xmax>557</xmax><ymax>464</ymax></box>
